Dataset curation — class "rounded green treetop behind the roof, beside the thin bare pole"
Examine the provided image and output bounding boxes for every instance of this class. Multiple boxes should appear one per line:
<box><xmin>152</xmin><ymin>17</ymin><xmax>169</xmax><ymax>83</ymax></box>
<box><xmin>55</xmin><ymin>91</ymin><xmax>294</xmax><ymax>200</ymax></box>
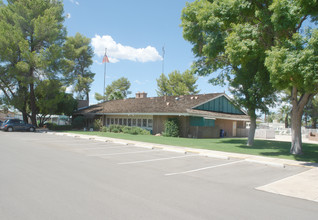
<box><xmin>157</xmin><ymin>70</ymin><xmax>199</xmax><ymax>96</ymax></box>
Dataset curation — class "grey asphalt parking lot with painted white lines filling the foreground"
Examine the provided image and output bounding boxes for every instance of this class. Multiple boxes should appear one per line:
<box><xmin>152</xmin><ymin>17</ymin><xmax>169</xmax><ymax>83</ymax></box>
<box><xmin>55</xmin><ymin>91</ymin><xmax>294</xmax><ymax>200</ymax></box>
<box><xmin>0</xmin><ymin>132</ymin><xmax>318</xmax><ymax>219</ymax></box>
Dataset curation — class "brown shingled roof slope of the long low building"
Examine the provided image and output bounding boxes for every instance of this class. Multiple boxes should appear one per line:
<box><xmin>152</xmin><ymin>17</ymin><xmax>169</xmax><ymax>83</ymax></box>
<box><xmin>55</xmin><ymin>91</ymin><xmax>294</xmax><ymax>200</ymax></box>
<box><xmin>76</xmin><ymin>93</ymin><xmax>224</xmax><ymax>114</ymax></box>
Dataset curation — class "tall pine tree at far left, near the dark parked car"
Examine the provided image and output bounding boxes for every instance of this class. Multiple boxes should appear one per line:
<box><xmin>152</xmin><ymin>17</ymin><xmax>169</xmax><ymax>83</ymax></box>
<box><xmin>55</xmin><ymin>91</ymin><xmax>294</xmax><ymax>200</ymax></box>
<box><xmin>0</xmin><ymin>0</ymin><xmax>66</xmax><ymax>125</ymax></box>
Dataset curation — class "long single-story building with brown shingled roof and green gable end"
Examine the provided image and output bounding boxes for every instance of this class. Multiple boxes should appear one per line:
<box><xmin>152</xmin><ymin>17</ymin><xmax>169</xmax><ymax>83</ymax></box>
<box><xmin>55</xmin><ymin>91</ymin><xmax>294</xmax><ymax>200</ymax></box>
<box><xmin>74</xmin><ymin>92</ymin><xmax>250</xmax><ymax>138</ymax></box>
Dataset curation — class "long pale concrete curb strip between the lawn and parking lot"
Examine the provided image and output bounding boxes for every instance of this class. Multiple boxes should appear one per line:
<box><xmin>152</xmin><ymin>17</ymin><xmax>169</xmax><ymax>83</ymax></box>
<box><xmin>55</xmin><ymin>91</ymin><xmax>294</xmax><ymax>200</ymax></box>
<box><xmin>47</xmin><ymin>132</ymin><xmax>318</xmax><ymax>168</ymax></box>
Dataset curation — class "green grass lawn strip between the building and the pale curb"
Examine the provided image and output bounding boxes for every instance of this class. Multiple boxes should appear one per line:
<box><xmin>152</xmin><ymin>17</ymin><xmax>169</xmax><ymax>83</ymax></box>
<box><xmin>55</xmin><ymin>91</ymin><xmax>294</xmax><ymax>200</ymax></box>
<box><xmin>63</xmin><ymin>131</ymin><xmax>318</xmax><ymax>163</ymax></box>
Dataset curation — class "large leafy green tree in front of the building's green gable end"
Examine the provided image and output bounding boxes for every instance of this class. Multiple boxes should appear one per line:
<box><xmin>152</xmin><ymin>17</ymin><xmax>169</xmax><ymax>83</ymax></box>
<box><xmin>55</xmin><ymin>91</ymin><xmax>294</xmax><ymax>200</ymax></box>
<box><xmin>181</xmin><ymin>0</ymin><xmax>275</xmax><ymax>145</ymax></box>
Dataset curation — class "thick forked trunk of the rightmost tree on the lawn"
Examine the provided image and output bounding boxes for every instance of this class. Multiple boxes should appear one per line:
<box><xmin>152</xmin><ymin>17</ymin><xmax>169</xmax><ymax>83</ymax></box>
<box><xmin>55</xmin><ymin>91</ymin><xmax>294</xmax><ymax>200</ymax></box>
<box><xmin>290</xmin><ymin>87</ymin><xmax>314</xmax><ymax>155</ymax></box>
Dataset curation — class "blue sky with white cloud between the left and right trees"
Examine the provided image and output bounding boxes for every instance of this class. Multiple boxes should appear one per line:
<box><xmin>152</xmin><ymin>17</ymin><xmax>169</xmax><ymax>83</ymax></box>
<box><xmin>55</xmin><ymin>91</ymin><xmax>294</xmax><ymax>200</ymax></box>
<box><xmin>64</xmin><ymin>0</ymin><xmax>225</xmax><ymax>104</ymax></box>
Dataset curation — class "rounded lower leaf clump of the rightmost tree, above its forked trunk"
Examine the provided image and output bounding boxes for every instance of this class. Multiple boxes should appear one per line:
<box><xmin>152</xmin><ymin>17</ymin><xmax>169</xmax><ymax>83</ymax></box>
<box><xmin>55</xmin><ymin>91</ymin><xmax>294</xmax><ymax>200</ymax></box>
<box><xmin>266</xmin><ymin>29</ymin><xmax>318</xmax><ymax>94</ymax></box>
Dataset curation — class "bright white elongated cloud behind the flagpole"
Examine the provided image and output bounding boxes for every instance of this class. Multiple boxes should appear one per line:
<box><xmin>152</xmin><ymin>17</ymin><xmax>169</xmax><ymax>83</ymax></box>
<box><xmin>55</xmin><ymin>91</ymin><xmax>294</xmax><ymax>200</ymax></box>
<box><xmin>92</xmin><ymin>35</ymin><xmax>162</xmax><ymax>63</ymax></box>
